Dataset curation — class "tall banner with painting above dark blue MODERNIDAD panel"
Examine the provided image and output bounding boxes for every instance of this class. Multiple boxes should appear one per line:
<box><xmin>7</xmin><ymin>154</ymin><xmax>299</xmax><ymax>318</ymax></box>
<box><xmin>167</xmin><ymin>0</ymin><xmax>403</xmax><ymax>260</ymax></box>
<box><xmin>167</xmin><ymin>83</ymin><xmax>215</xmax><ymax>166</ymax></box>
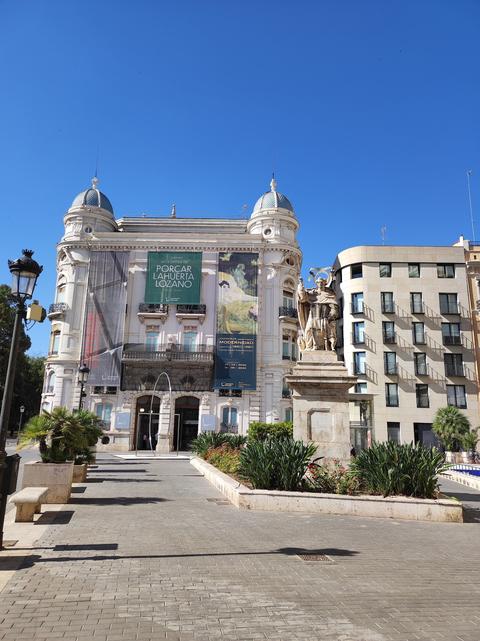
<box><xmin>214</xmin><ymin>252</ymin><xmax>258</xmax><ymax>390</ymax></box>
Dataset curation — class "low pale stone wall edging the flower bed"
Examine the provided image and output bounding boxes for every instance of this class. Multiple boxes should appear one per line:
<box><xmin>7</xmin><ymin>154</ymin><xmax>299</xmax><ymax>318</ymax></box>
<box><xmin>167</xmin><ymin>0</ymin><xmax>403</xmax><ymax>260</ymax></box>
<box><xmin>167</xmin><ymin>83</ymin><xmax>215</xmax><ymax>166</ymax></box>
<box><xmin>190</xmin><ymin>457</ymin><xmax>463</xmax><ymax>523</ymax></box>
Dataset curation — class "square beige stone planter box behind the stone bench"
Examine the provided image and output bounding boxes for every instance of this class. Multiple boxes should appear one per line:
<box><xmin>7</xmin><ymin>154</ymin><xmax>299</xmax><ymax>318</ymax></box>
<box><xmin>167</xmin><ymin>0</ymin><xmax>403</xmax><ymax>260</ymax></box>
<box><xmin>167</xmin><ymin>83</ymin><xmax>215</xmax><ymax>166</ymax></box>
<box><xmin>22</xmin><ymin>463</ymin><xmax>73</xmax><ymax>504</ymax></box>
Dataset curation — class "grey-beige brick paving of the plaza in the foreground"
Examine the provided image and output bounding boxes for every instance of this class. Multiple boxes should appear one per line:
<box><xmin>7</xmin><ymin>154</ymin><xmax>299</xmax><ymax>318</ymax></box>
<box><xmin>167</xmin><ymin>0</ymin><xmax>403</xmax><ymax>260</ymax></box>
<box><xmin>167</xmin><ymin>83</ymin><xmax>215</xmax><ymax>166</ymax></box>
<box><xmin>0</xmin><ymin>458</ymin><xmax>480</xmax><ymax>641</ymax></box>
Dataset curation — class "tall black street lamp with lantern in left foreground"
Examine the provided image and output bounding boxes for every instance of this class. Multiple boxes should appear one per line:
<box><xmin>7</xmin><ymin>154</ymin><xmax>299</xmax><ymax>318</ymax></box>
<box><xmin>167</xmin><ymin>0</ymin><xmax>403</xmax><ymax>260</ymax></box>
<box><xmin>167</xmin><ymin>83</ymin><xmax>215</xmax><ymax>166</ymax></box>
<box><xmin>0</xmin><ymin>249</ymin><xmax>43</xmax><ymax>549</ymax></box>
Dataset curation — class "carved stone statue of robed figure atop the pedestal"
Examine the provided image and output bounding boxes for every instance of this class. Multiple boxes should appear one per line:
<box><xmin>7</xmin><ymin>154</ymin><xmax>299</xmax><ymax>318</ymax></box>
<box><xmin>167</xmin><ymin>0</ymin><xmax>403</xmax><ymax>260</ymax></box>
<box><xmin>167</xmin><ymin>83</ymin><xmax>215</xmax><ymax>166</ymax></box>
<box><xmin>297</xmin><ymin>270</ymin><xmax>340</xmax><ymax>352</ymax></box>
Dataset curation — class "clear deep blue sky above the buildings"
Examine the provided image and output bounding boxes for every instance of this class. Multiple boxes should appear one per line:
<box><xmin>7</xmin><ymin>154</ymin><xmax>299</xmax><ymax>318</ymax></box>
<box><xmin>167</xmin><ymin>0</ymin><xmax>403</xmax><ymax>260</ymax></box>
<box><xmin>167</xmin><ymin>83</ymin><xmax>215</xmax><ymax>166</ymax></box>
<box><xmin>0</xmin><ymin>0</ymin><xmax>480</xmax><ymax>354</ymax></box>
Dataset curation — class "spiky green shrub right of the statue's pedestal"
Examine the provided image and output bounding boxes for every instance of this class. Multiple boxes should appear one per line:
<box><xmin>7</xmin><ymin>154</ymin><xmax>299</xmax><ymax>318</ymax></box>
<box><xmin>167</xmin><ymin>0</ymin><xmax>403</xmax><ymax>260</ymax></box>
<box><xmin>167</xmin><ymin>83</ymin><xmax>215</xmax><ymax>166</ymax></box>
<box><xmin>350</xmin><ymin>441</ymin><xmax>449</xmax><ymax>499</ymax></box>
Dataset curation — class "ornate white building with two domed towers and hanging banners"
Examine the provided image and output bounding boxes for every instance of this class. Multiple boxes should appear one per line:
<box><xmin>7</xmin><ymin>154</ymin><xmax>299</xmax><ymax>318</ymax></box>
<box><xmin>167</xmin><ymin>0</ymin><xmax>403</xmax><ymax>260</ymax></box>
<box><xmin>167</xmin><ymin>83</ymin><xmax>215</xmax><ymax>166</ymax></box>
<box><xmin>42</xmin><ymin>179</ymin><xmax>302</xmax><ymax>451</ymax></box>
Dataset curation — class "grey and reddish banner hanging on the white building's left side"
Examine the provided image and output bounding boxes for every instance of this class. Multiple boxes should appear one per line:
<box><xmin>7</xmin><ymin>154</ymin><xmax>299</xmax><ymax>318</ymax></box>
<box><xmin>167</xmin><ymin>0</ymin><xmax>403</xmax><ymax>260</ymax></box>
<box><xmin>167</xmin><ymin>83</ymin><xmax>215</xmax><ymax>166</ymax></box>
<box><xmin>83</xmin><ymin>251</ymin><xmax>129</xmax><ymax>387</ymax></box>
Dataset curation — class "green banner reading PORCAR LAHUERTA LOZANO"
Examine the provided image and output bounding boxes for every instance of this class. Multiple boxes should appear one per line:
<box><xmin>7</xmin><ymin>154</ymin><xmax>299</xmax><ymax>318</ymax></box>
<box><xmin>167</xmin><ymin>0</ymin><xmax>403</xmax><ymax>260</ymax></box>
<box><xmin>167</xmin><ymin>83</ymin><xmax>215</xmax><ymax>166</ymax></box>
<box><xmin>145</xmin><ymin>252</ymin><xmax>202</xmax><ymax>305</ymax></box>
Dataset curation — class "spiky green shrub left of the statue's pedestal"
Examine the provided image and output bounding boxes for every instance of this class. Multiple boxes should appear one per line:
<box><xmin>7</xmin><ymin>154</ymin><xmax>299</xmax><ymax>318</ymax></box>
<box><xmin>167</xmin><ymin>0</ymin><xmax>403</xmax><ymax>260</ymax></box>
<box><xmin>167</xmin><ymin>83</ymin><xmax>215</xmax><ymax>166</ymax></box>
<box><xmin>238</xmin><ymin>437</ymin><xmax>316</xmax><ymax>490</ymax></box>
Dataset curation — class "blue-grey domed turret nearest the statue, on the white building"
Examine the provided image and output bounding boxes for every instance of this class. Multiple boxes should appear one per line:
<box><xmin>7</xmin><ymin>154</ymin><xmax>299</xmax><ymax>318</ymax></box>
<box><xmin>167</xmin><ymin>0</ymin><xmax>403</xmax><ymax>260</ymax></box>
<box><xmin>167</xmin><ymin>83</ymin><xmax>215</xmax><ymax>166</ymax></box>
<box><xmin>247</xmin><ymin>177</ymin><xmax>299</xmax><ymax>246</ymax></box>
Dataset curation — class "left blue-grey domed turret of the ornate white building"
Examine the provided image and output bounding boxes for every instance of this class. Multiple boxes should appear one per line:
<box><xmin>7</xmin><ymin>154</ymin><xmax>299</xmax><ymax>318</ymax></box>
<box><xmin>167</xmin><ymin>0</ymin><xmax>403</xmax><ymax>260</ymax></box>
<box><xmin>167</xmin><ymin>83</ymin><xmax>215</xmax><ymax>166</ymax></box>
<box><xmin>63</xmin><ymin>176</ymin><xmax>117</xmax><ymax>240</ymax></box>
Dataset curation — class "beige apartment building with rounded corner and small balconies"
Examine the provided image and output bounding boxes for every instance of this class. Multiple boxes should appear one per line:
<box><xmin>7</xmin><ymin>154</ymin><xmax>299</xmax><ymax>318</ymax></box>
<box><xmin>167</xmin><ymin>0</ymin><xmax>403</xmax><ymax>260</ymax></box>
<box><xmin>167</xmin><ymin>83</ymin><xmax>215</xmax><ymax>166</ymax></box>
<box><xmin>334</xmin><ymin>246</ymin><xmax>480</xmax><ymax>446</ymax></box>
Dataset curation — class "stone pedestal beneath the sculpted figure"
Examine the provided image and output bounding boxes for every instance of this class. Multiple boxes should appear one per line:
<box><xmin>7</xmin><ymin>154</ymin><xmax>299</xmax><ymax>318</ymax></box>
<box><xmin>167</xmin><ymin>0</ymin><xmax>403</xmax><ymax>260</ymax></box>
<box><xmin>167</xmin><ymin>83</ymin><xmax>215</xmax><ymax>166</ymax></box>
<box><xmin>285</xmin><ymin>350</ymin><xmax>357</xmax><ymax>465</ymax></box>
